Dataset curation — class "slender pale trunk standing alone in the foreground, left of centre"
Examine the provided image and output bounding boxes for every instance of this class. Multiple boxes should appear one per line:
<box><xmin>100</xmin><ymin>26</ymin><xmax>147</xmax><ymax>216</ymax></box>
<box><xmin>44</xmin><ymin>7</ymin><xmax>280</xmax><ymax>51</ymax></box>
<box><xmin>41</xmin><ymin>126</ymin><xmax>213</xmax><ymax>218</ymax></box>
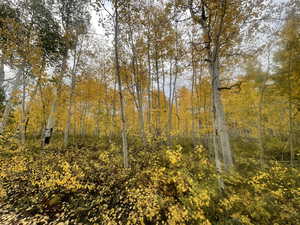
<box><xmin>114</xmin><ymin>2</ymin><xmax>129</xmax><ymax>168</ymax></box>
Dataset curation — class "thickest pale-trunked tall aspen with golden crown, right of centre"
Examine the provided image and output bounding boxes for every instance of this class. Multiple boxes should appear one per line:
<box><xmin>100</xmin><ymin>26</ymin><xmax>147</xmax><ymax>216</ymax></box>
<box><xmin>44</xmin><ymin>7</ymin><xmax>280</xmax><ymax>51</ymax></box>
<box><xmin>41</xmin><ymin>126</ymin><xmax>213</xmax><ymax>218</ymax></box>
<box><xmin>187</xmin><ymin>0</ymin><xmax>274</xmax><ymax>170</ymax></box>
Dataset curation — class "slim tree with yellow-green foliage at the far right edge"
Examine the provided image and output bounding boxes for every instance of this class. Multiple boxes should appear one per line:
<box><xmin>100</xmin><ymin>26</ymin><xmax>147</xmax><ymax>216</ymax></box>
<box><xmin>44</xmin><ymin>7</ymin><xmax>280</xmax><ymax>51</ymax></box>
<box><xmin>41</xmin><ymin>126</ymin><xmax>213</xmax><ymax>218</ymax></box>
<box><xmin>275</xmin><ymin>5</ymin><xmax>300</xmax><ymax>165</ymax></box>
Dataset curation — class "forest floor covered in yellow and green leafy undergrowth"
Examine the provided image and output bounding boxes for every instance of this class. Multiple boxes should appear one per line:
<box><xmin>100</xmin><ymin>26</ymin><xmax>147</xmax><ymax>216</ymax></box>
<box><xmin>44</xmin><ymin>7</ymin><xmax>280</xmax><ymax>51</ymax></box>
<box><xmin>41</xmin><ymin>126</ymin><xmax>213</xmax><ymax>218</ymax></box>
<box><xmin>0</xmin><ymin>134</ymin><xmax>300</xmax><ymax>225</ymax></box>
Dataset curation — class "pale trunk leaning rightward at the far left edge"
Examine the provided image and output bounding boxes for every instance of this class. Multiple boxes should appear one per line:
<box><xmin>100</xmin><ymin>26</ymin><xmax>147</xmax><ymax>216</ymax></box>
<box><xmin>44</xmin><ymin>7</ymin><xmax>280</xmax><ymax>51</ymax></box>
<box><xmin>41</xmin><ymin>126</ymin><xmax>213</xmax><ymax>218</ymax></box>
<box><xmin>0</xmin><ymin>65</ymin><xmax>24</xmax><ymax>134</ymax></box>
